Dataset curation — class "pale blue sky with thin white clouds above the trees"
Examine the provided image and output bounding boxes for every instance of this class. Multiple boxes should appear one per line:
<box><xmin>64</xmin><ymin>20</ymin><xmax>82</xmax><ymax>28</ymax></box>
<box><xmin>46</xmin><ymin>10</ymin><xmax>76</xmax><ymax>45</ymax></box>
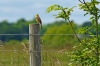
<box><xmin>0</xmin><ymin>0</ymin><xmax>96</xmax><ymax>24</ymax></box>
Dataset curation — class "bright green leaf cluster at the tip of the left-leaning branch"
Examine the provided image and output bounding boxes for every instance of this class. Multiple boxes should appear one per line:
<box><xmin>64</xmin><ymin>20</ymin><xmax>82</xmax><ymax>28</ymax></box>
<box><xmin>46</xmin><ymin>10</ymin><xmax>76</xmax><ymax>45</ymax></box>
<box><xmin>46</xmin><ymin>4</ymin><xmax>76</xmax><ymax>20</ymax></box>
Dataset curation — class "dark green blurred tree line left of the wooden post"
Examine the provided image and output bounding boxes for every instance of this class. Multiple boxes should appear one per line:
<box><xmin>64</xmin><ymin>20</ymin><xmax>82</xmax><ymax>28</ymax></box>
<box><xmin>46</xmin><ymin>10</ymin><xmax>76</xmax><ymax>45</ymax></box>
<box><xmin>0</xmin><ymin>18</ymin><xmax>35</xmax><ymax>41</ymax></box>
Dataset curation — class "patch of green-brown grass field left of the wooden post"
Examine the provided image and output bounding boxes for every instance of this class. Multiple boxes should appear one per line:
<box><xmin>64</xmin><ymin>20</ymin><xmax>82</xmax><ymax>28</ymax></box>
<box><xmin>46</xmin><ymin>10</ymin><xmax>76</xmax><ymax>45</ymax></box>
<box><xmin>0</xmin><ymin>45</ymin><xmax>29</xmax><ymax>66</ymax></box>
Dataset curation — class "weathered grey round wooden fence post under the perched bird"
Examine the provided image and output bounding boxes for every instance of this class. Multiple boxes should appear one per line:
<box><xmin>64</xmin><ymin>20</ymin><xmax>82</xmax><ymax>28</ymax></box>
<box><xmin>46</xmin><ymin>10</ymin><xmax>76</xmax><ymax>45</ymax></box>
<box><xmin>29</xmin><ymin>24</ymin><xmax>41</xmax><ymax>66</ymax></box>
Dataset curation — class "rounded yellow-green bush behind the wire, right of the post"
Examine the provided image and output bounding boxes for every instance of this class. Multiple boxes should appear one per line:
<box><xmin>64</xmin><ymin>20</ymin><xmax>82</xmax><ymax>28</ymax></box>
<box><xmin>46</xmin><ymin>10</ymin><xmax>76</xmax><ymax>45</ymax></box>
<box><xmin>42</xmin><ymin>22</ymin><xmax>76</xmax><ymax>48</ymax></box>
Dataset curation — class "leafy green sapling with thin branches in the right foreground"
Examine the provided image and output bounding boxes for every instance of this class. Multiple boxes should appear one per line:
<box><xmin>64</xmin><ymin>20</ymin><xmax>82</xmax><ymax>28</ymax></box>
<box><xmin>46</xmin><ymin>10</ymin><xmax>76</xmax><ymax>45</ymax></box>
<box><xmin>47</xmin><ymin>0</ymin><xmax>100</xmax><ymax>66</ymax></box>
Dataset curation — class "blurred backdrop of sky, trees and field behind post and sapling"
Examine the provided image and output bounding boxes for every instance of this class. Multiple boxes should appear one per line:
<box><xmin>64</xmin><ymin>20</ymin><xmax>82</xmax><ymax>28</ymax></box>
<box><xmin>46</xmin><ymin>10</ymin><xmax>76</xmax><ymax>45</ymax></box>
<box><xmin>0</xmin><ymin>0</ymin><xmax>100</xmax><ymax>66</ymax></box>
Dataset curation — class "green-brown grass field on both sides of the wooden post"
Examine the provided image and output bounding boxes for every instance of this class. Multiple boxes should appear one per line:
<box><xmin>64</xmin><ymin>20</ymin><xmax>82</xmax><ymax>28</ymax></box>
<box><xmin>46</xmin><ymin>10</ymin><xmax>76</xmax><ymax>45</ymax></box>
<box><xmin>0</xmin><ymin>42</ymin><xmax>72</xmax><ymax>66</ymax></box>
